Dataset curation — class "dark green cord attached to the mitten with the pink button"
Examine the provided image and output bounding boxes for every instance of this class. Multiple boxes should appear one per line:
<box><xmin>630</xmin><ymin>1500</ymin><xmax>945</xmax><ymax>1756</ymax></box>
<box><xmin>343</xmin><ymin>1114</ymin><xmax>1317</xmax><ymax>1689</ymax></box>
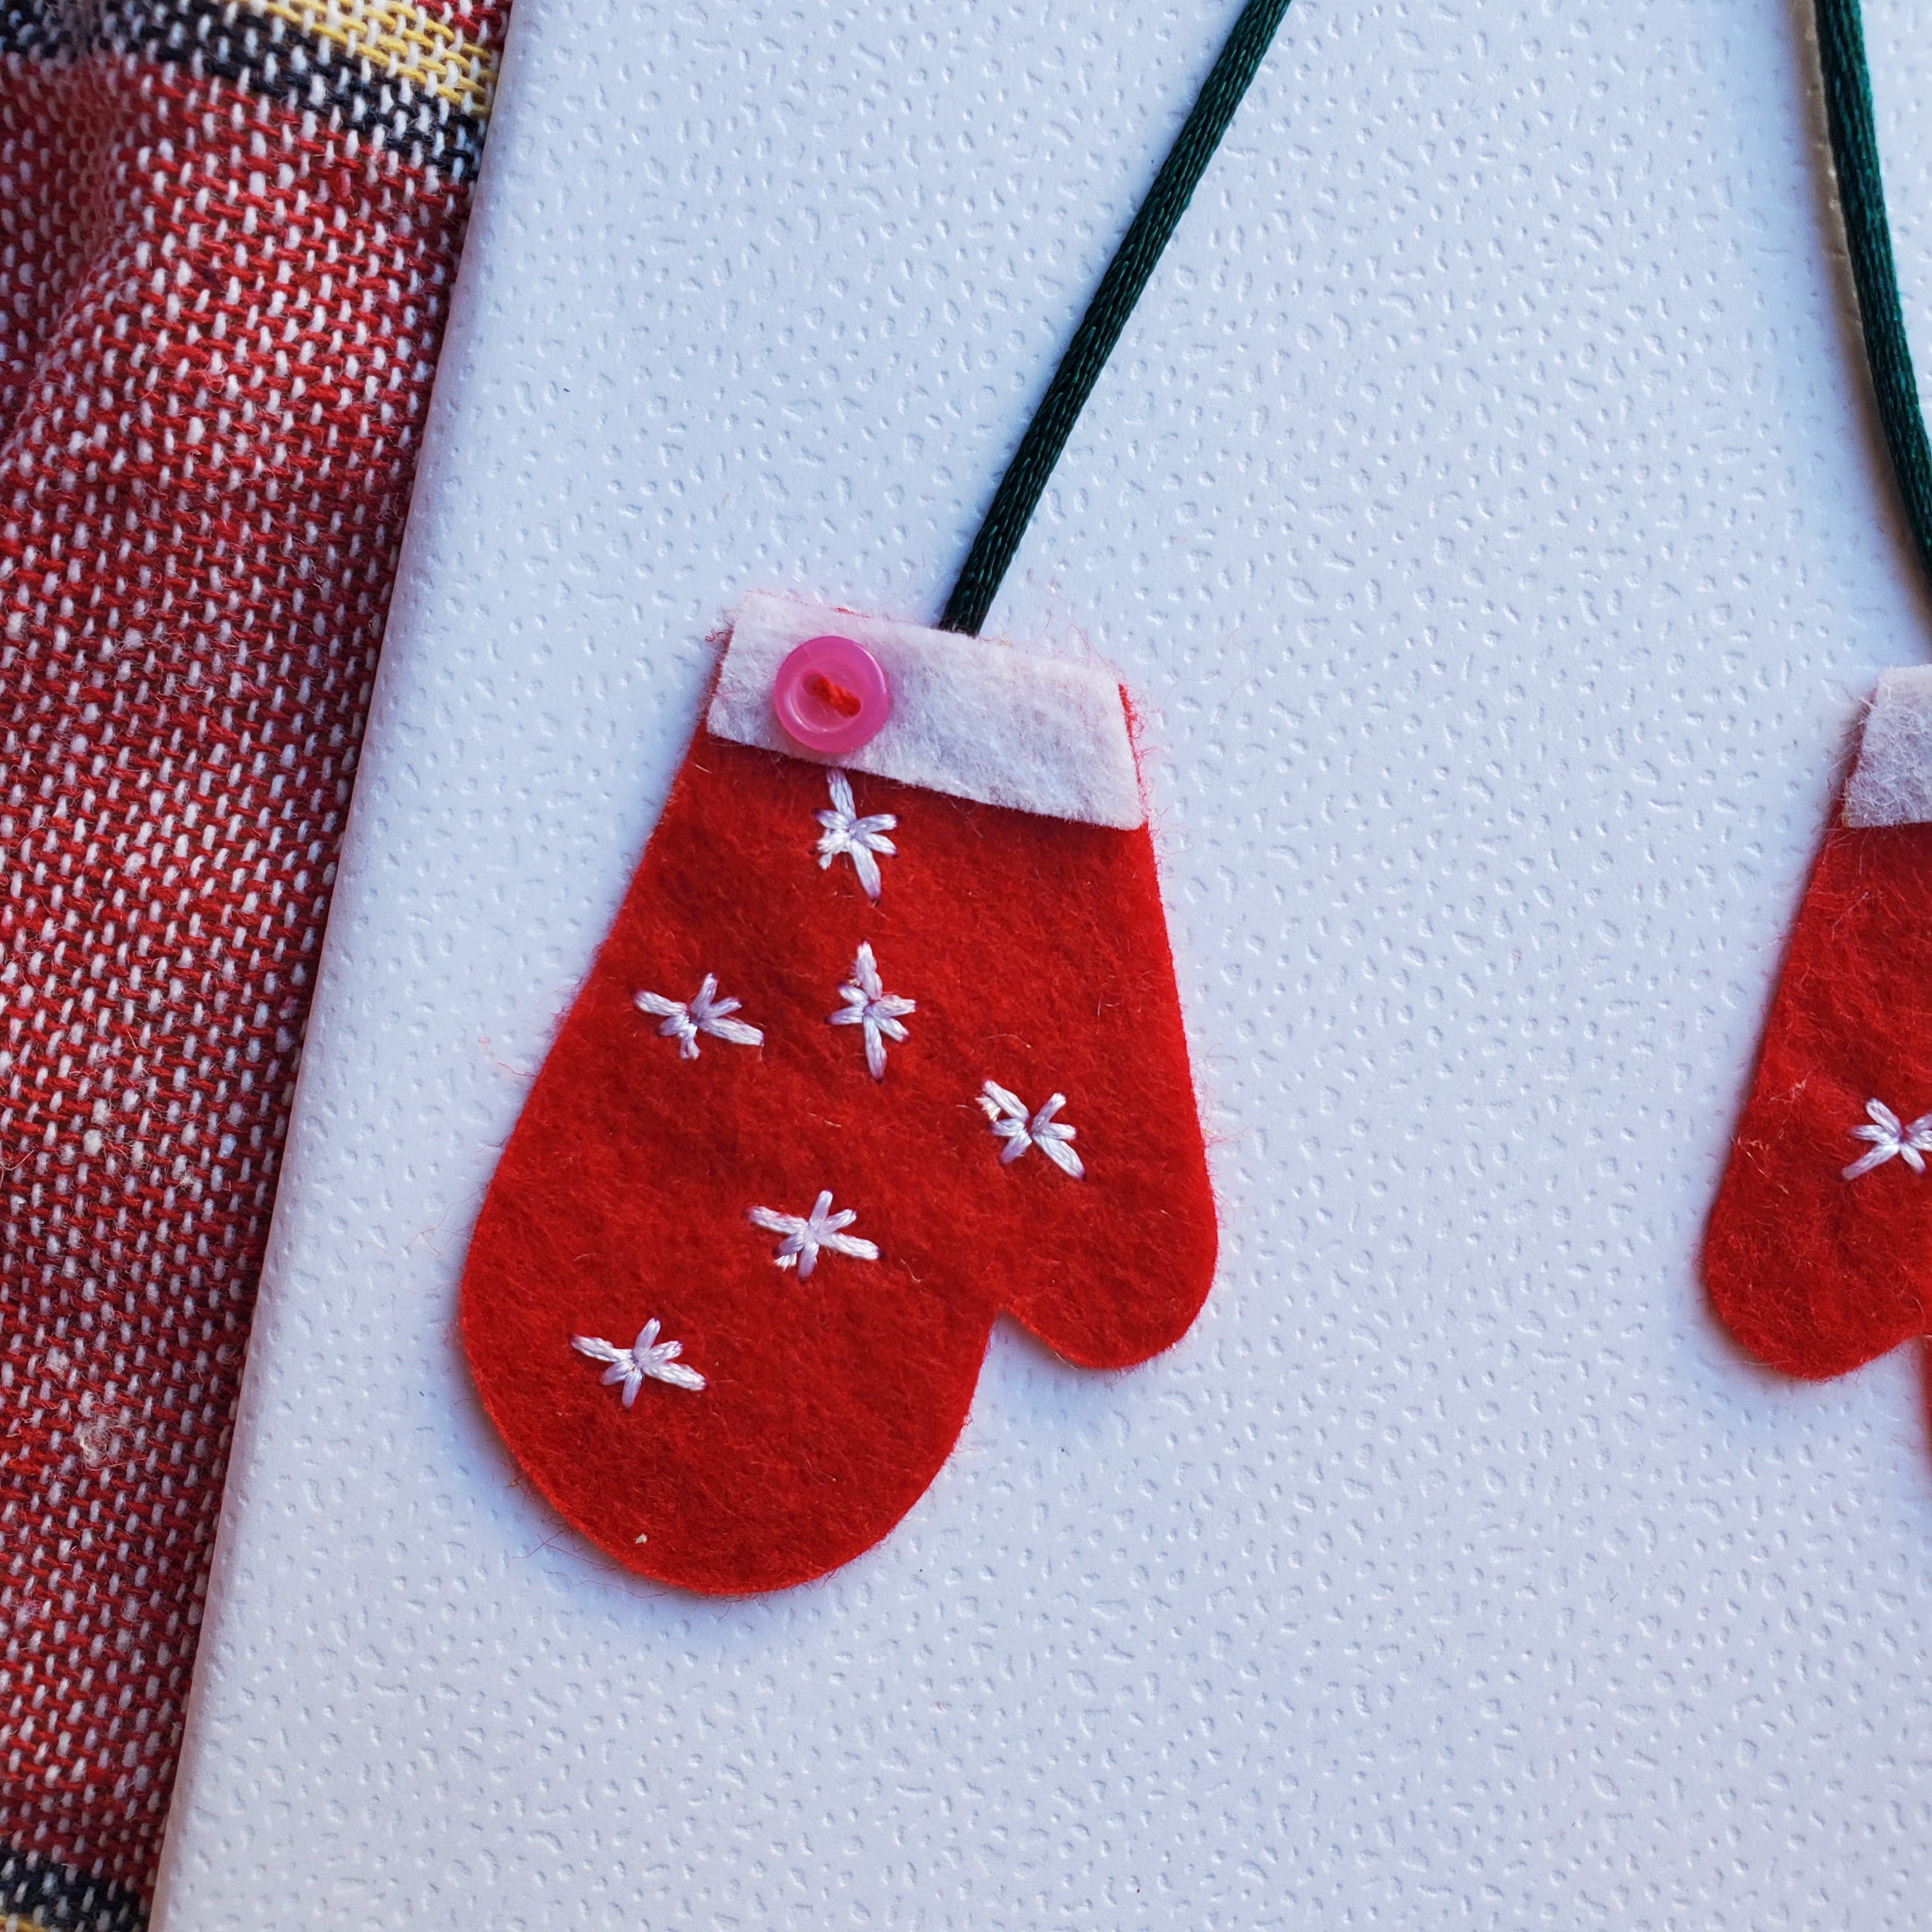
<box><xmin>939</xmin><ymin>0</ymin><xmax>1298</xmax><ymax>636</ymax></box>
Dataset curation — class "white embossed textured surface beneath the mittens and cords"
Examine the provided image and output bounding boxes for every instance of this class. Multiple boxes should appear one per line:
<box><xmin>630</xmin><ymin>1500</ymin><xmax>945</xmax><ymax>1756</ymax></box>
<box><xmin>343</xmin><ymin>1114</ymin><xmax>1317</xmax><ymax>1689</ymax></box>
<box><xmin>160</xmin><ymin>0</ymin><xmax>1932</xmax><ymax>1932</ymax></box>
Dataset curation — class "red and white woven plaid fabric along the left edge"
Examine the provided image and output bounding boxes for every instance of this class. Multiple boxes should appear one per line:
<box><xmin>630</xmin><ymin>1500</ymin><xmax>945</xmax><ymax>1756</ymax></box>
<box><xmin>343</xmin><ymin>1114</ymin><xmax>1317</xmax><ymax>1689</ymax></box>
<box><xmin>0</xmin><ymin>0</ymin><xmax>508</xmax><ymax>1928</ymax></box>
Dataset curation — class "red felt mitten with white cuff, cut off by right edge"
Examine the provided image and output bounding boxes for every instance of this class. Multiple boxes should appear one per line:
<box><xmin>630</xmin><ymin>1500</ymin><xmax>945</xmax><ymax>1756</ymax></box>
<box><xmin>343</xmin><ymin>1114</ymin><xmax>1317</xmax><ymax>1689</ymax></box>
<box><xmin>1704</xmin><ymin>670</ymin><xmax>1932</xmax><ymax>1377</ymax></box>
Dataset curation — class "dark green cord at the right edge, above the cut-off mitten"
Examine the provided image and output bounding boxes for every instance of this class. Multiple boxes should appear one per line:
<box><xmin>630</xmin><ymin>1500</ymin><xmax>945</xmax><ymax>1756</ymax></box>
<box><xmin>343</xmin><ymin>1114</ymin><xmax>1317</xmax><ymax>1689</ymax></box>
<box><xmin>1818</xmin><ymin>0</ymin><xmax>1932</xmax><ymax>583</ymax></box>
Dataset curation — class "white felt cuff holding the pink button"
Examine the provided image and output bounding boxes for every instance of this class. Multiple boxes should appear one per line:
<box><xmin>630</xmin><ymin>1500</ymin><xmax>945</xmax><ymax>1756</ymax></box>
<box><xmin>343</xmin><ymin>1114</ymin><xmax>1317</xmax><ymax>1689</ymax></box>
<box><xmin>705</xmin><ymin>593</ymin><xmax>1146</xmax><ymax>827</ymax></box>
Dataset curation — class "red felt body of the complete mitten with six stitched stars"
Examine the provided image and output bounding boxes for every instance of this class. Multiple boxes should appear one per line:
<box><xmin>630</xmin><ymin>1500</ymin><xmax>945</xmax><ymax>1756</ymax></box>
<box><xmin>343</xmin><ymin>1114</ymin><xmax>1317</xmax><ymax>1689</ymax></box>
<box><xmin>462</xmin><ymin>732</ymin><xmax>1215</xmax><ymax>1592</ymax></box>
